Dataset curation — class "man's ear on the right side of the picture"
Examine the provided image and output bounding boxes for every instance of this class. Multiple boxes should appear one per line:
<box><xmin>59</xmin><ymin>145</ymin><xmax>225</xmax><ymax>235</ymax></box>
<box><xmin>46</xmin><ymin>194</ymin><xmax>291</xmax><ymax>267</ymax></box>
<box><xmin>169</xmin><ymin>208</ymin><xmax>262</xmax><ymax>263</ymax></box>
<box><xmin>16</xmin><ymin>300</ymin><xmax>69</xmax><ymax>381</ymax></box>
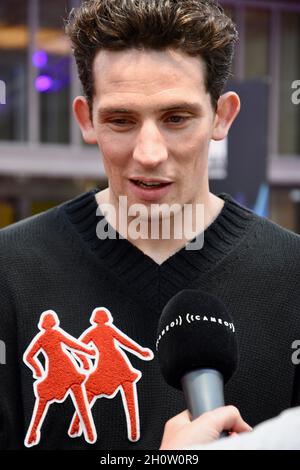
<box><xmin>212</xmin><ymin>91</ymin><xmax>241</xmax><ymax>140</ymax></box>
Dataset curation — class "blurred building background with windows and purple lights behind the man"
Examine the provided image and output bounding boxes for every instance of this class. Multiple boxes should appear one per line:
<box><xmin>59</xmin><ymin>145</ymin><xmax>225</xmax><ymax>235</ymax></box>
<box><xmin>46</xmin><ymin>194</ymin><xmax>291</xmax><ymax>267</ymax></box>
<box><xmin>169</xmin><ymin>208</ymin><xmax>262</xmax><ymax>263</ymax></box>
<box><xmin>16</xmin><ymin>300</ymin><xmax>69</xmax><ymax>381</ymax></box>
<box><xmin>0</xmin><ymin>0</ymin><xmax>300</xmax><ymax>233</ymax></box>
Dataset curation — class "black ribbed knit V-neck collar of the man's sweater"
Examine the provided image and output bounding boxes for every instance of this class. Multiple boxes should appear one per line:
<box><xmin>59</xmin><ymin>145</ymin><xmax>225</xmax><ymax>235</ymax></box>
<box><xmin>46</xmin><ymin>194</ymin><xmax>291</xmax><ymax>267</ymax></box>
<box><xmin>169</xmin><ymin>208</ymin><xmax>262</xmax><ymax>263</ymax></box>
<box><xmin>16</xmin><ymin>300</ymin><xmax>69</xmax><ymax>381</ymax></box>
<box><xmin>62</xmin><ymin>189</ymin><xmax>256</xmax><ymax>308</ymax></box>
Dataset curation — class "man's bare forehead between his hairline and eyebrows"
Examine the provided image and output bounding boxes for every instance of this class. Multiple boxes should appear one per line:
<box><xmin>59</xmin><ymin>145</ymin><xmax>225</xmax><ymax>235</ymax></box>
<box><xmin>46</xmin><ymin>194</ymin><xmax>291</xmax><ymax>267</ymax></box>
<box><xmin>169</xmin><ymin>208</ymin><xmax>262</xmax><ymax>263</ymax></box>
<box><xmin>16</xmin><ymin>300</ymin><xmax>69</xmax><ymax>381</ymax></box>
<box><xmin>93</xmin><ymin>49</ymin><xmax>208</xmax><ymax>108</ymax></box>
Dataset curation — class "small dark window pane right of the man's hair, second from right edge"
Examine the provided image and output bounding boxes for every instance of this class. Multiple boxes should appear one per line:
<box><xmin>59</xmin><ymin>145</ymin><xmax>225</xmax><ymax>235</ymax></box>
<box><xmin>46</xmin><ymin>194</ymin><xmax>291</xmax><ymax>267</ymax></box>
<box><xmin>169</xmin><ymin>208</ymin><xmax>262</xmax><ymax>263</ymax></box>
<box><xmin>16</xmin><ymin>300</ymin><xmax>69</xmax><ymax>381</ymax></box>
<box><xmin>245</xmin><ymin>9</ymin><xmax>271</xmax><ymax>79</ymax></box>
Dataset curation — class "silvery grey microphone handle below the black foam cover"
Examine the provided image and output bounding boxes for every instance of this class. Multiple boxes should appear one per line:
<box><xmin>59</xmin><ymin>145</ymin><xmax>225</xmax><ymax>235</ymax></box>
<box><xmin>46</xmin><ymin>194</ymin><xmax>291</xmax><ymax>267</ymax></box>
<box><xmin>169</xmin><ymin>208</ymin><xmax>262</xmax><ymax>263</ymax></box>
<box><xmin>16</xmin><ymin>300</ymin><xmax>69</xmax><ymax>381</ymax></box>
<box><xmin>181</xmin><ymin>369</ymin><xmax>228</xmax><ymax>438</ymax></box>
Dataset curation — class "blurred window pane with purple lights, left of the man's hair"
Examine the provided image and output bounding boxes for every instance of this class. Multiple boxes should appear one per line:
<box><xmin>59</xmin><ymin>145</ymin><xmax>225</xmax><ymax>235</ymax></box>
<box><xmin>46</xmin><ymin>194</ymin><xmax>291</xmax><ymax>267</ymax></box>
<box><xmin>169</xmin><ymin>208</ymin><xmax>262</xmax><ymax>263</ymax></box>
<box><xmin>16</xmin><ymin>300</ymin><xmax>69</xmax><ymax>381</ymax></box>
<box><xmin>37</xmin><ymin>0</ymin><xmax>71</xmax><ymax>143</ymax></box>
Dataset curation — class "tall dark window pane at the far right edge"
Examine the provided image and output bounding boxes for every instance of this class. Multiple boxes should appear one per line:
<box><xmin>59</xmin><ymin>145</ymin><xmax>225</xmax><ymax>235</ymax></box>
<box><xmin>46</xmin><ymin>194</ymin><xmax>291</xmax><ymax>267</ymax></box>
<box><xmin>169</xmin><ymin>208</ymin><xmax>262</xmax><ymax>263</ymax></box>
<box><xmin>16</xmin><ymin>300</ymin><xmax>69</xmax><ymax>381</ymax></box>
<box><xmin>279</xmin><ymin>12</ymin><xmax>300</xmax><ymax>155</ymax></box>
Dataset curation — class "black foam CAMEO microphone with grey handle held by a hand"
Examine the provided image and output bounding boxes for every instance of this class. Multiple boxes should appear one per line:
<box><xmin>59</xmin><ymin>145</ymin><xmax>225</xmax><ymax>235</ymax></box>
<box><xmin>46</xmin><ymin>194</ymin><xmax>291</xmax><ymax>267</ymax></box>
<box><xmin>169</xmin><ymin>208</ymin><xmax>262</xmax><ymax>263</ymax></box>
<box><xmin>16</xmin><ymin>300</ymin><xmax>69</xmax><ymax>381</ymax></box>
<box><xmin>156</xmin><ymin>289</ymin><xmax>238</xmax><ymax>428</ymax></box>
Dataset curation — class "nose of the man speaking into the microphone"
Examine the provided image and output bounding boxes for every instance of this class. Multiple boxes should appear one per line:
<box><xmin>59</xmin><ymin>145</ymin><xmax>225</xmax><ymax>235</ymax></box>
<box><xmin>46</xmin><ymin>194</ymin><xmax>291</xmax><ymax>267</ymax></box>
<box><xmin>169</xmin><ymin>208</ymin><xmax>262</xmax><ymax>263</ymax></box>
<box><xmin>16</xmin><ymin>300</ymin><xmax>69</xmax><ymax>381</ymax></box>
<box><xmin>133</xmin><ymin>121</ymin><xmax>168</xmax><ymax>167</ymax></box>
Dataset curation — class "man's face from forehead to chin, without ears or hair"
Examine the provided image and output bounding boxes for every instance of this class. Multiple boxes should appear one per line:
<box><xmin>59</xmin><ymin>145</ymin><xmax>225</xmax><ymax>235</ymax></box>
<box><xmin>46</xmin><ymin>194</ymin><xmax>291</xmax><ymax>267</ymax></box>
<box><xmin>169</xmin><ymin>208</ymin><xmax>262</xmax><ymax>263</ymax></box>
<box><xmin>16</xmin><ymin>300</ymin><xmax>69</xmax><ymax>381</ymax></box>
<box><xmin>86</xmin><ymin>49</ymin><xmax>220</xmax><ymax>206</ymax></box>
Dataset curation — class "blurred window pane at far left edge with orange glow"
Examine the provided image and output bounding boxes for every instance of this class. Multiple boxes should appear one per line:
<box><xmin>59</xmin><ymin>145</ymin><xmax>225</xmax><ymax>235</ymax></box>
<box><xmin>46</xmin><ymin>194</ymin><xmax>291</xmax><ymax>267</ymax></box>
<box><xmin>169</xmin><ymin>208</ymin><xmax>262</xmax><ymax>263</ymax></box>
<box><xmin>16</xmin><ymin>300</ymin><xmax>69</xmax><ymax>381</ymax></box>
<box><xmin>0</xmin><ymin>0</ymin><xmax>28</xmax><ymax>141</ymax></box>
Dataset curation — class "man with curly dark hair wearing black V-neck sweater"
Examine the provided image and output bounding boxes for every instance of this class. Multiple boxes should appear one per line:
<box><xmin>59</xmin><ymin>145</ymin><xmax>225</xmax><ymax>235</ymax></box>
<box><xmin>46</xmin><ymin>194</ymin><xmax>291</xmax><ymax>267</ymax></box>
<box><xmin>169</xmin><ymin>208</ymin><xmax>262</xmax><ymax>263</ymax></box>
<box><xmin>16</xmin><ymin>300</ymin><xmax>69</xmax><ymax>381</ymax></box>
<box><xmin>0</xmin><ymin>0</ymin><xmax>300</xmax><ymax>450</ymax></box>
